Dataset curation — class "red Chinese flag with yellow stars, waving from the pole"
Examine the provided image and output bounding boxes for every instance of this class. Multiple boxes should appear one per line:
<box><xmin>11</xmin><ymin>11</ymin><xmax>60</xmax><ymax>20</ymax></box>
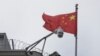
<box><xmin>42</xmin><ymin>12</ymin><xmax>77</xmax><ymax>34</ymax></box>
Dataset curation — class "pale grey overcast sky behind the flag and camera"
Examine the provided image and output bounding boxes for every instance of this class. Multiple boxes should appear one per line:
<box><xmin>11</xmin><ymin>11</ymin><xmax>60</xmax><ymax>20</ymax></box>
<box><xmin>0</xmin><ymin>0</ymin><xmax>100</xmax><ymax>56</ymax></box>
